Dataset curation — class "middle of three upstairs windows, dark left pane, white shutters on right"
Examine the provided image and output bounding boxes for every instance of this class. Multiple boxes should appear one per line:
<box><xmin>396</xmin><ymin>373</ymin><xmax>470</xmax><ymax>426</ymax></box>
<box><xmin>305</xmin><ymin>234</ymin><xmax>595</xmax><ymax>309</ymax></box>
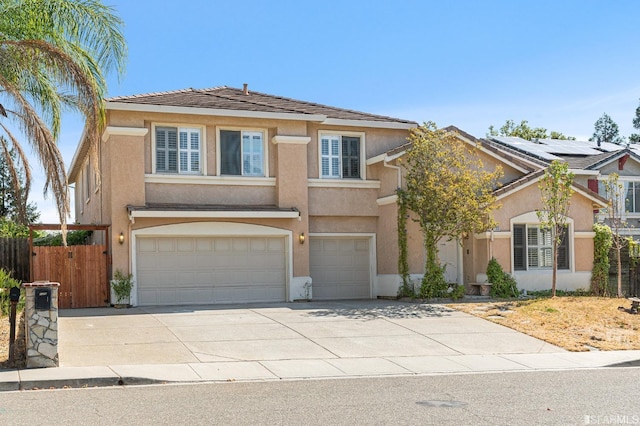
<box><xmin>220</xmin><ymin>130</ymin><xmax>265</xmax><ymax>176</ymax></box>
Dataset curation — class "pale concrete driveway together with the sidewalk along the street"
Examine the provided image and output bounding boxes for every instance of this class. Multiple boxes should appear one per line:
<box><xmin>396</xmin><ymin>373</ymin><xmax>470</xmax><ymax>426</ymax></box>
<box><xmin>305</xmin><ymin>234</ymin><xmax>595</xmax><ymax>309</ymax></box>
<box><xmin>0</xmin><ymin>300</ymin><xmax>640</xmax><ymax>390</ymax></box>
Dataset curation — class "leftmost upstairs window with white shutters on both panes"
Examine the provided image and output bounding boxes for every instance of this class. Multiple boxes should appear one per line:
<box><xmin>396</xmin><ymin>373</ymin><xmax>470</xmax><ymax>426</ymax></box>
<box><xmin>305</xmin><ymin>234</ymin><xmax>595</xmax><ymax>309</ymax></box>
<box><xmin>155</xmin><ymin>127</ymin><xmax>202</xmax><ymax>174</ymax></box>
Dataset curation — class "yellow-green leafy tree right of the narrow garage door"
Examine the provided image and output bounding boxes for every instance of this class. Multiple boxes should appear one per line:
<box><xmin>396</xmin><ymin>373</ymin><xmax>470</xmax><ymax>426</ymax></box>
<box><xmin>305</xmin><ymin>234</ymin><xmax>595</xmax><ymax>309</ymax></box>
<box><xmin>398</xmin><ymin>122</ymin><xmax>502</xmax><ymax>298</ymax></box>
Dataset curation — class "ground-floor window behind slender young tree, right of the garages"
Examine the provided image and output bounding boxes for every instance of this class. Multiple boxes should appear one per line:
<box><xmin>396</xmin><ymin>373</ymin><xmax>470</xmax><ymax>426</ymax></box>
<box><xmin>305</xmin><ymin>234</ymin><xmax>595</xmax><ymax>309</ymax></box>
<box><xmin>513</xmin><ymin>224</ymin><xmax>569</xmax><ymax>271</ymax></box>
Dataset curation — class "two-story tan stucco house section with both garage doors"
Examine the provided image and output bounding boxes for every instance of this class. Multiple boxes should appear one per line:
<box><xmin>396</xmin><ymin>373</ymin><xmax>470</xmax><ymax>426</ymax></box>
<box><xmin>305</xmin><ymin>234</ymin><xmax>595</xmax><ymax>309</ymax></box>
<box><xmin>69</xmin><ymin>86</ymin><xmax>423</xmax><ymax>305</ymax></box>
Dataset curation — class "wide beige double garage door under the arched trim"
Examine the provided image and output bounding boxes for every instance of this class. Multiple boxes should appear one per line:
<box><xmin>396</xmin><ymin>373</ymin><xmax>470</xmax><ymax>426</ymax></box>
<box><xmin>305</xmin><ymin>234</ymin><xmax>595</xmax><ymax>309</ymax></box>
<box><xmin>136</xmin><ymin>237</ymin><xmax>286</xmax><ymax>305</ymax></box>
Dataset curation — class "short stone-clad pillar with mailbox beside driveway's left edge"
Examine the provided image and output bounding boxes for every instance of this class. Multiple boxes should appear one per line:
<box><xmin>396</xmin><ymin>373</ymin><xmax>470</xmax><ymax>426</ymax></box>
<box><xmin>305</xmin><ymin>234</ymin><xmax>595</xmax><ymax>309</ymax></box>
<box><xmin>22</xmin><ymin>281</ymin><xmax>60</xmax><ymax>368</ymax></box>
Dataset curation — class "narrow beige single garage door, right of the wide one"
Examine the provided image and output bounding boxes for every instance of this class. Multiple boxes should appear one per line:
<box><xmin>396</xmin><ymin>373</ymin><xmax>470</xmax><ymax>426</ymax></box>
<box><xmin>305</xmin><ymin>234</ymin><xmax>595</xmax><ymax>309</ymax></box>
<box><xmin>309</xmin><ymin>237</ymin><xmax>371</xmax><ymax>300</ymax></box>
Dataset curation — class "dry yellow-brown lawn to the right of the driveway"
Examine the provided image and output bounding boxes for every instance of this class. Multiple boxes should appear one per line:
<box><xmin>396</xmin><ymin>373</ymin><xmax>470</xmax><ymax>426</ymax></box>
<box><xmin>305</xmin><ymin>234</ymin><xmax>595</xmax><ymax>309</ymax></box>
<box><xmin>448</xmin><ymin>296</ymin><xmax>640</xmax><ymax>351</ymax></box>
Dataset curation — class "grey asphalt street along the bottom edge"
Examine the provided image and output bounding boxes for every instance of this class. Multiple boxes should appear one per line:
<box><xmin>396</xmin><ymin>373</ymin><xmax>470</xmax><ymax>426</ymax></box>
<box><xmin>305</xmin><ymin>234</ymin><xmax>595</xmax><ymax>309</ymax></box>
<box><xmin>0</xmin><ymin>367</ymin><xmax>640</xmax><ymax>425</ymax></box>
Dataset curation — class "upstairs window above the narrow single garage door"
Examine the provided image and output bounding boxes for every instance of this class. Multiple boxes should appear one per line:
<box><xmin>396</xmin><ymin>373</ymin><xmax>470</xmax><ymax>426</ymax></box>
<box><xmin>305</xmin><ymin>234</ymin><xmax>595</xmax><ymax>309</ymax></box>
<box><xmin>320</xmin><ymin>134</ymin><xmax>362</xmax><ymax>179</ymax></box>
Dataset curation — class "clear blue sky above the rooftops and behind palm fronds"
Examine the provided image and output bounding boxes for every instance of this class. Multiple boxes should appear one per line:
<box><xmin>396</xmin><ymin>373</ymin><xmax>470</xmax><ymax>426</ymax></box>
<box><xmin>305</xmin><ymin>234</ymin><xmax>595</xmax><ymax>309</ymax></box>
<box><xmin>31</xmin><ymin>0</ymin><xmax>640</xmax><ymax>223</ymax></box>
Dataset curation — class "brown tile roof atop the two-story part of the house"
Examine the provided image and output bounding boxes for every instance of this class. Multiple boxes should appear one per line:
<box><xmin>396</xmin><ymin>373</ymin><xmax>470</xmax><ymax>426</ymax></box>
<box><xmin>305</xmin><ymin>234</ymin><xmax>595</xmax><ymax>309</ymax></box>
<box><xmin>106</xmin><ymin>86</ymin><xmax>417</xmax><ymax>125</ymax></box>
